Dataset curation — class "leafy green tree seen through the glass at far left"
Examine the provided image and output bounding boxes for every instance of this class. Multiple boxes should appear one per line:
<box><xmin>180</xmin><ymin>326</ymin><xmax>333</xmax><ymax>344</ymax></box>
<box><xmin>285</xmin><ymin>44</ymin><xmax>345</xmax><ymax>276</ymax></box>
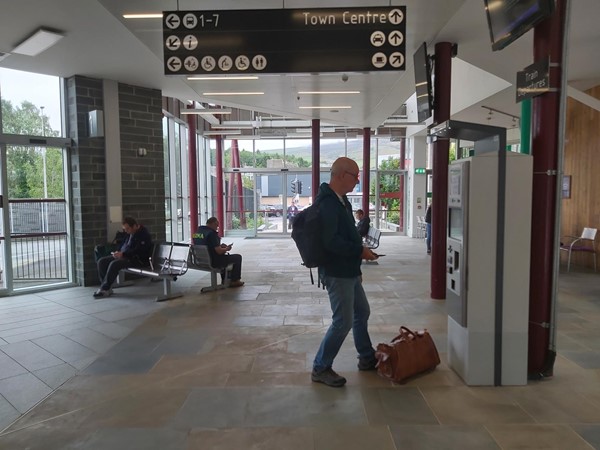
<box><xmin>1</xmin><ymin>99</ymin><xmax>64</xmax><ymax>198</ymax></box>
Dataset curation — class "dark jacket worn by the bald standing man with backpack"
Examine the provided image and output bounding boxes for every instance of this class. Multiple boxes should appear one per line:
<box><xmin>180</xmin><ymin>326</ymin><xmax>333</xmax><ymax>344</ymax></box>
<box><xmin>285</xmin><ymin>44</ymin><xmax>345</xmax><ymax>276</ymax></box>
<box><xmin>315</xmin><ymin>183</ymin><xmax>363</xmax><ymax>278</ymax></box>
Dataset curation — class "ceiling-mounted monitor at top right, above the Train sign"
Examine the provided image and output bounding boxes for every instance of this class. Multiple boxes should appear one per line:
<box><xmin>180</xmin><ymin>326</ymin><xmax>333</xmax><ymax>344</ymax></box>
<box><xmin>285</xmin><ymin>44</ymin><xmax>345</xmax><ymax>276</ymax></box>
<box><xmin>484</xmin><ymin>0</ymin><xmax>554</xmax><ymax>51</ymax></box>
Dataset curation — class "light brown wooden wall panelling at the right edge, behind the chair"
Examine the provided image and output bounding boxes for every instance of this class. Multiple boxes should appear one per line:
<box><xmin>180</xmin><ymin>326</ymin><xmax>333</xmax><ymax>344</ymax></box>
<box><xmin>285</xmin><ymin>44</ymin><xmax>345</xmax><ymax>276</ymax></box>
<box><xmin>560</xmin><ymin>86</ymin><xmax>600</xmax><ymax>268</ymax></box>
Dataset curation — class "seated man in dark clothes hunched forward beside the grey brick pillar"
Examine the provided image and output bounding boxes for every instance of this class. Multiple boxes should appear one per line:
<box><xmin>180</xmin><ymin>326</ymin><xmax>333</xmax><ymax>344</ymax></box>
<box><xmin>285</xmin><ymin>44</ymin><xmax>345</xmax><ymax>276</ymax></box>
<box><xmin>94</xmin><ymin>217</ymin><xmax>152</xmax><ymax>298</ymax></box>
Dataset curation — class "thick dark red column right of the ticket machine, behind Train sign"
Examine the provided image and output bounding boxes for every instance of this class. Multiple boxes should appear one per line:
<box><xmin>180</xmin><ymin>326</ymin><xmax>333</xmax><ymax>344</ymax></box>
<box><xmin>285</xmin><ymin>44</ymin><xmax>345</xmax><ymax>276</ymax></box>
<box><xmin>528</xmin><ymin>0</ymin><xmax>567</xmax><ymax>378</ymax></box>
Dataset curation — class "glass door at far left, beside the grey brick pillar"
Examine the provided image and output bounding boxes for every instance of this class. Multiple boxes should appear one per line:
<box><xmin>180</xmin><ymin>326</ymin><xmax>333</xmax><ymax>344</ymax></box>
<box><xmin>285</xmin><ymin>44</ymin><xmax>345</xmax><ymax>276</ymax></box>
<box><xmin>0</xmin><ymin>138</ymin><xmax>72</xmax><ymax>293</ymax></box>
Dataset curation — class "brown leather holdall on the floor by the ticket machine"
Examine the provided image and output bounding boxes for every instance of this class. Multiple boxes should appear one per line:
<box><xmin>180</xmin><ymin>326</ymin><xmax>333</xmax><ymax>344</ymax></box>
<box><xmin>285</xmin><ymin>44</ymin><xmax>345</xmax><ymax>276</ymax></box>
<box><xmin>375</xmin><ymin>327</ymin><xmax>440</xmax><ymax>383</ymax></box>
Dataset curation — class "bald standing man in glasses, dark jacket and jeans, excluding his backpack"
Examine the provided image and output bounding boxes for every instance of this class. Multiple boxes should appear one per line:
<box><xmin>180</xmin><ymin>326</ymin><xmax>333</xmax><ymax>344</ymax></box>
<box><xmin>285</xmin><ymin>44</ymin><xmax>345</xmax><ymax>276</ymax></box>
<box><xmin>311</xmin><ymin>157</ymin><xmax>378</xmax><ymax>387</ymax></box>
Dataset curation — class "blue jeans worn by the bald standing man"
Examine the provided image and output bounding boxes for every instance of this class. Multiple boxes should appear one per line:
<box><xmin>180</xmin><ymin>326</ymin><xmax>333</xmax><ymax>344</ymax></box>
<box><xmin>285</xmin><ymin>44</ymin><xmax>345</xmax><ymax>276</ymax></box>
<box><xmin>313</xmin><ymin>276</ymin><xmax>375</xmax><ymax>372</ymax></box>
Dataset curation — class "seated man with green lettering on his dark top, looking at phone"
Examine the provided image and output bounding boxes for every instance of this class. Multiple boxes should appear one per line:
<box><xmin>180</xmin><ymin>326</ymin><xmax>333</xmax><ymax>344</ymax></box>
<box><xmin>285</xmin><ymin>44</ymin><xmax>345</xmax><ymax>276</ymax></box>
<box><xmin>193</xmin><ymin>217</ymin><xmax>244</xmax><ymax>287</ymax></box>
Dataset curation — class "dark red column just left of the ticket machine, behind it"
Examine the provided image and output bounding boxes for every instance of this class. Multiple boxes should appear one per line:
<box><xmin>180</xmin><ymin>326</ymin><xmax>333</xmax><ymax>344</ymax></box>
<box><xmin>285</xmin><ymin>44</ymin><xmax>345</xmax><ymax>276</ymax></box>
<box><xmin>431</xmin><ymin>42</ymin><xmax>452</xmax><ymax>300</ymax></box>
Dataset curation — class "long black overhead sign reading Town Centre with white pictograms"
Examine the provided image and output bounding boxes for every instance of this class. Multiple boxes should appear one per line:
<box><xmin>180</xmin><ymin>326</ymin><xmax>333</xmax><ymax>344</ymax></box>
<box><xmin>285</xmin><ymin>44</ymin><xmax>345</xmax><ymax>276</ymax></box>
<box><xmin>163</xmin><ymin>6</ymin><xmax>406</xmax><ymax>75</ymax></box>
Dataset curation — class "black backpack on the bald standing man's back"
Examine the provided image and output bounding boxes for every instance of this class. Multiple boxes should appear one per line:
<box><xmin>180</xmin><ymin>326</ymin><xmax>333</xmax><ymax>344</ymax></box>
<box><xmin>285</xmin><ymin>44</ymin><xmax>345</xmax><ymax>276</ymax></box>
<box><xmin>292</xmin><ymin>202</ymin><xmax>329</xmax><ymax>284</ymax></box>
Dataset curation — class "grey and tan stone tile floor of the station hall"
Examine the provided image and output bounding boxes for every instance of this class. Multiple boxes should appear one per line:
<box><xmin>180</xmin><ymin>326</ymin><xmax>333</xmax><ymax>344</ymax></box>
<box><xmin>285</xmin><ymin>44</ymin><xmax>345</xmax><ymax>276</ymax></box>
<box><xmin>0</xmin><ymin>236</ymin><xmax>600</xmax><ymax>450</ymax></box>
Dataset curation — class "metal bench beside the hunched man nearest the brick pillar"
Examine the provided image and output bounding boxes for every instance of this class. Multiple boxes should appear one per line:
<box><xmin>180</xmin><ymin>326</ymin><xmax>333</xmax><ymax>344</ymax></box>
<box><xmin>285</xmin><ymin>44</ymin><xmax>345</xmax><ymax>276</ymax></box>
<box><xmin>119</xmin><ymin>242</ymin><xmax>190</xmax><ymax>302</ymax></box>
